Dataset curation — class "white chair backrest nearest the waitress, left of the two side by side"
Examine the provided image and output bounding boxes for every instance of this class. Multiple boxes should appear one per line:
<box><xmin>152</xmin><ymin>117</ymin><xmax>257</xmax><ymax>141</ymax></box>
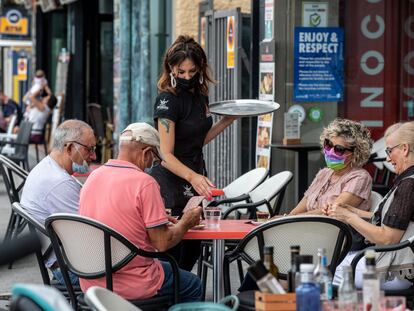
<box><xmin>223</xmin><ymin>167</ymin><xmax>268</xmax><ymax>198</ymax></box>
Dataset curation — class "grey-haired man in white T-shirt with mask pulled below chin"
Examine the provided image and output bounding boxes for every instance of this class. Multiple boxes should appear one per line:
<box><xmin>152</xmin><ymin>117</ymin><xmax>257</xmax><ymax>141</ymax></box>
<box><xmin>21</xmin><ymin>120</ymin><xmax>96</xmax><ymax>284</ymax></box>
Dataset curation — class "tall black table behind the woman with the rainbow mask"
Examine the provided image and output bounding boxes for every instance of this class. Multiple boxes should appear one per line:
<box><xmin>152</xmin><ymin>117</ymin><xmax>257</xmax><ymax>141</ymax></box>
<box><xmin>270</xmin><ymin>143</ymin><xmax>321</xmax><ymax>202</ymax></box>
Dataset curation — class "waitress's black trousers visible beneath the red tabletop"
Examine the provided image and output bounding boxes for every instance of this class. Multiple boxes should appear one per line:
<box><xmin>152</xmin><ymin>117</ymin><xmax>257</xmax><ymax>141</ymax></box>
<box><xmin>167</xmin><ymin>240</ymin><xmax>201</xmax><ymax>271</ymax></box>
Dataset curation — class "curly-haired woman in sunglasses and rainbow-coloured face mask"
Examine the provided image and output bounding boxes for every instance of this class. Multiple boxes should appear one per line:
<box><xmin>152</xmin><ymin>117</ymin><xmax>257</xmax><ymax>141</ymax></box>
<box><xmin>291</xmin><ymin>119</ymin><xmax>372</xmax><ymax>221</ymax></box>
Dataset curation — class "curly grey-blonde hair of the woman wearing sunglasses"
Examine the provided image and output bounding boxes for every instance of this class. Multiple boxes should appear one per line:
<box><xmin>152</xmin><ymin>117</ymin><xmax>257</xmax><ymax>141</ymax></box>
<box><xmin>320</xmin><ymin>118</ymin><xmax>373</xmax><ymax>167</ymax></box>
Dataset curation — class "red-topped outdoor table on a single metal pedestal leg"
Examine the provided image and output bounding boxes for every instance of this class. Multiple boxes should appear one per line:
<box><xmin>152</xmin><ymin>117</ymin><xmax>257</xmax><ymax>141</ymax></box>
<box><xmin>183</xmin><ymin>219</ymin><xmax>257</xmax><ymax>302</ymax></box>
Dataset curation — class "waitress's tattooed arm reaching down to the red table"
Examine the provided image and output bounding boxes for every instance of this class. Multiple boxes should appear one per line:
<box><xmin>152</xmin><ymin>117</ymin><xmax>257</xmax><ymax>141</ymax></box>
<box><xmin>157</xmin><ymin>118</ymin><xmax>214</xmax><ymax>198</ymax></box>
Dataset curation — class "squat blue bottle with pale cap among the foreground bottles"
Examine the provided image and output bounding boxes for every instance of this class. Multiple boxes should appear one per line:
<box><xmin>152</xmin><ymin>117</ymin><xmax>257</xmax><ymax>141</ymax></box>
<box><xmin>296</xmin><ymin>263</ymin><xmax>321</xmax><ymax>311</ymax></box>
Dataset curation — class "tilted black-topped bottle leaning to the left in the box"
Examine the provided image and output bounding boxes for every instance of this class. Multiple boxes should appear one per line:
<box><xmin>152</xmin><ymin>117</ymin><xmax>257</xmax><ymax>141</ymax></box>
<box><xmin>247</xmin><ymin>260</ymin><xmax>286</xmax><ymax>294</ymax></box>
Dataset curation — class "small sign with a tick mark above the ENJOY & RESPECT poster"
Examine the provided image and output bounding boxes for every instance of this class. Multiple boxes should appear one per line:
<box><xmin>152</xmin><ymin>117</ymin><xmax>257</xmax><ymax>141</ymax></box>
<box><xmin>302</xmin><ymin>2</ymin><xmax>328</xmax><ymax>27</ymax></box>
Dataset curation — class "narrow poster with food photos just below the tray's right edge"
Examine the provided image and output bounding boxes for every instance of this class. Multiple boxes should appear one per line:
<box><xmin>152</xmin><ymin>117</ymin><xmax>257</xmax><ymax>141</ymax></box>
<box><xmin>256</xmin><ymin>113</ymin><xmax>273</xmax><ymax>169</ymax></box>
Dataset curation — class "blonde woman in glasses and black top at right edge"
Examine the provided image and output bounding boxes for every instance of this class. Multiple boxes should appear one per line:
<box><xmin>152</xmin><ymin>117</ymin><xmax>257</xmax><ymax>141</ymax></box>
<box><xmin>326</xmin><ymin>121</ymin><xmax>414</xmax><ymax>290</ymax></box>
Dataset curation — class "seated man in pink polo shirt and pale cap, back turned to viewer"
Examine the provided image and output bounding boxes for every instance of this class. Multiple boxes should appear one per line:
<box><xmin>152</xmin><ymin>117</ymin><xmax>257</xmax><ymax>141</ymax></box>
<box><xmin>79</xmin><ymin>123</ymin><xmax>202</xmax><ymax>302</ymax></box>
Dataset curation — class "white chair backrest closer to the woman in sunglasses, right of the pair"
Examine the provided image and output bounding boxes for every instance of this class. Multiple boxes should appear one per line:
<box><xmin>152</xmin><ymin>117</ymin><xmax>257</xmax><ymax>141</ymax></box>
<box><xmin>249</xmin><ymin>171</ymin><xmax>293</xmax><ymax>215</ymax></box>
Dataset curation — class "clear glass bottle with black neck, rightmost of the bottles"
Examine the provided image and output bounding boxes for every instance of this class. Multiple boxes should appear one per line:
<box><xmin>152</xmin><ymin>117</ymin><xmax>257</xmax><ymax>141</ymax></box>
<box><xmin>362</xmin><ymin>250</ymin><xmax>380</xmax><ymax>311</ymax></box>
